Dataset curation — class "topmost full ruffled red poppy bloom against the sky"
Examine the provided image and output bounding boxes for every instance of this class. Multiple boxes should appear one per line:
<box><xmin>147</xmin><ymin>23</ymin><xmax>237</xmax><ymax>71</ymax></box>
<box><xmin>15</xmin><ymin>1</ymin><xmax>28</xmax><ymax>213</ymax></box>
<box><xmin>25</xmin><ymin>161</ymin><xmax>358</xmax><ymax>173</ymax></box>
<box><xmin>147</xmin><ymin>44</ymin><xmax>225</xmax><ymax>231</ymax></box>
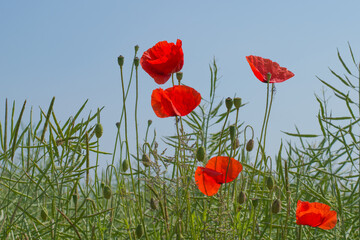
<box><xmin>140</xmin><ymin>39</ymin><xmax>184</xmax><ymax>84</ymax></box>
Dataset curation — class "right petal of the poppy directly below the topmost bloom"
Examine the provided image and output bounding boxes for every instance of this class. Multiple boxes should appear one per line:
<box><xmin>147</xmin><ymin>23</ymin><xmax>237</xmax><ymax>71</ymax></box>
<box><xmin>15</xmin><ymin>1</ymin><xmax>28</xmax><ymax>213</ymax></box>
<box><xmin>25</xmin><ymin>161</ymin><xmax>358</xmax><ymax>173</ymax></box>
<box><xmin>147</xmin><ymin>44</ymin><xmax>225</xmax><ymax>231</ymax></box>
<box><xmin>165</xmin><ymin>85</ymin><xmax>201</xmax><ymax>116</ymax></box>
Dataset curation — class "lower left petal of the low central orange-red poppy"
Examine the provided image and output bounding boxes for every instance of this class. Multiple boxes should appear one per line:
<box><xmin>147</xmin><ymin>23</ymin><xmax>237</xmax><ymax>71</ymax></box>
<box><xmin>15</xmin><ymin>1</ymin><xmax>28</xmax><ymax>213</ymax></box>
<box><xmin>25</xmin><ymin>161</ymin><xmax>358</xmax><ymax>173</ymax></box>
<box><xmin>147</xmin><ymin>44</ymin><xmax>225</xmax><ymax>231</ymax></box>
<box><xmin>195</xmin><ymin>167</ymin><xmax>221</xmax><ymax>196</ymax></box>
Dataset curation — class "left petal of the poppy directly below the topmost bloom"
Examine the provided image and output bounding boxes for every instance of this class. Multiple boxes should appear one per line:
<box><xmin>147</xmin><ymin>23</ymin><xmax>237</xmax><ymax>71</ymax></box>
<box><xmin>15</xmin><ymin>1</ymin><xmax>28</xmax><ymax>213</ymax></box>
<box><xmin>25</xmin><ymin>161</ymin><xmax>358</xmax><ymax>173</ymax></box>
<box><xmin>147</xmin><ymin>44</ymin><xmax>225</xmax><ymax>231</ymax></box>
<box><xmin>151</xmin><ymin>88</ymin><xmax>176</xmax><ymax>118</ymax></box>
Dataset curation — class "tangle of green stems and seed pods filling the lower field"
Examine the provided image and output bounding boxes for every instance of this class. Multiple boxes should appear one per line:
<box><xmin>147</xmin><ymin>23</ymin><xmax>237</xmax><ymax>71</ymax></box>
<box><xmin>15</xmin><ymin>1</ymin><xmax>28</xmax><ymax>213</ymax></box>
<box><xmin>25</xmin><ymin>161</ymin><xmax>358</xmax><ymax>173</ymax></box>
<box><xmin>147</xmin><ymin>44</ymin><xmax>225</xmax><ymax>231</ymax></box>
<box><xmin>0</xmin><ymin>45</ymin><xmax>360</xmax><ymax>239</ymax></box>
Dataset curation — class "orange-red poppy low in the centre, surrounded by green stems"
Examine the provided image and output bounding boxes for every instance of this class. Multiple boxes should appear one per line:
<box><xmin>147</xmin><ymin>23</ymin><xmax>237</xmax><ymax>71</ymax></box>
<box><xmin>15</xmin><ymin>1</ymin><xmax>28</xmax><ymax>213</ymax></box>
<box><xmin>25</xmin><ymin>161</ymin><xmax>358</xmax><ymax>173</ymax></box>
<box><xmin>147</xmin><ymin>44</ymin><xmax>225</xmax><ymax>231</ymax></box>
<box><xmin>195</xmin><ymin>157</ymin><xmax>242</xmax><ymax>196</ymax></box>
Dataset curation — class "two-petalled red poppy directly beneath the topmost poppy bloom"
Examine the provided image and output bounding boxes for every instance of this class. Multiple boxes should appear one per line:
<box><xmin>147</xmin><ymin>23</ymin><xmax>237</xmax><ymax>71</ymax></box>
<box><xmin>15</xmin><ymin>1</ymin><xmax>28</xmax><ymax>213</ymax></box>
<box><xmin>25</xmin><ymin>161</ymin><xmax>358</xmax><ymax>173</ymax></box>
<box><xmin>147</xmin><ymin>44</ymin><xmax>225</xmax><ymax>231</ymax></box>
<box><xmin>151</xmin><ymin>85</ymin><xmax>201</xmax><ymax>118</ymax></box>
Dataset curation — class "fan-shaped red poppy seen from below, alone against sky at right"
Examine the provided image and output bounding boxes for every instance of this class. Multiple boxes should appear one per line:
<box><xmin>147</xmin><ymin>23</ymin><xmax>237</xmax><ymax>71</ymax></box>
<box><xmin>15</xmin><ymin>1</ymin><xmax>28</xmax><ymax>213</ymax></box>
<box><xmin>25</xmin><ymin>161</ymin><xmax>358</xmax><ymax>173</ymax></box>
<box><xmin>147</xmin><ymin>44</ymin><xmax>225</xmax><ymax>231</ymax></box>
<box><xmin>246</xmin><ymin>55</ymin><xmax>295</xmax><ymax>83</ymax></box>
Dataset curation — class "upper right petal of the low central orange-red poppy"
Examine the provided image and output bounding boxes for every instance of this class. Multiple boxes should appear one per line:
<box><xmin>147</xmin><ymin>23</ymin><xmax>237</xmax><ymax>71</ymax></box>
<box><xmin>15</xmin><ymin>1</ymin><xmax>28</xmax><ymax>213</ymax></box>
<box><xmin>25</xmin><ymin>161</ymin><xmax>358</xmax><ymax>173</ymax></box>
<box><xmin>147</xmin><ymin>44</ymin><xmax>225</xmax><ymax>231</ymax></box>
<box><xmin>205</xmin><ymin>156</ymin><xmax>243</xmax><ymax>183</ymax></box>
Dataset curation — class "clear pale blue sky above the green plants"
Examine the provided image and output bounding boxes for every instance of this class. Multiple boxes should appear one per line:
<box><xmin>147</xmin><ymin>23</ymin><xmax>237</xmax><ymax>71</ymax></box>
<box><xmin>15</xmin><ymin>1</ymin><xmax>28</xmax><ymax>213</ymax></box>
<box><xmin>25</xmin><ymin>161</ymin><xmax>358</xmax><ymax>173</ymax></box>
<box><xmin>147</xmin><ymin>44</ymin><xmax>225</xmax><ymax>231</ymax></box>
<box><xmin>0</xmin><ymin>0</ymin><xmax>360</xmax><ymax>167</ymax></box>
